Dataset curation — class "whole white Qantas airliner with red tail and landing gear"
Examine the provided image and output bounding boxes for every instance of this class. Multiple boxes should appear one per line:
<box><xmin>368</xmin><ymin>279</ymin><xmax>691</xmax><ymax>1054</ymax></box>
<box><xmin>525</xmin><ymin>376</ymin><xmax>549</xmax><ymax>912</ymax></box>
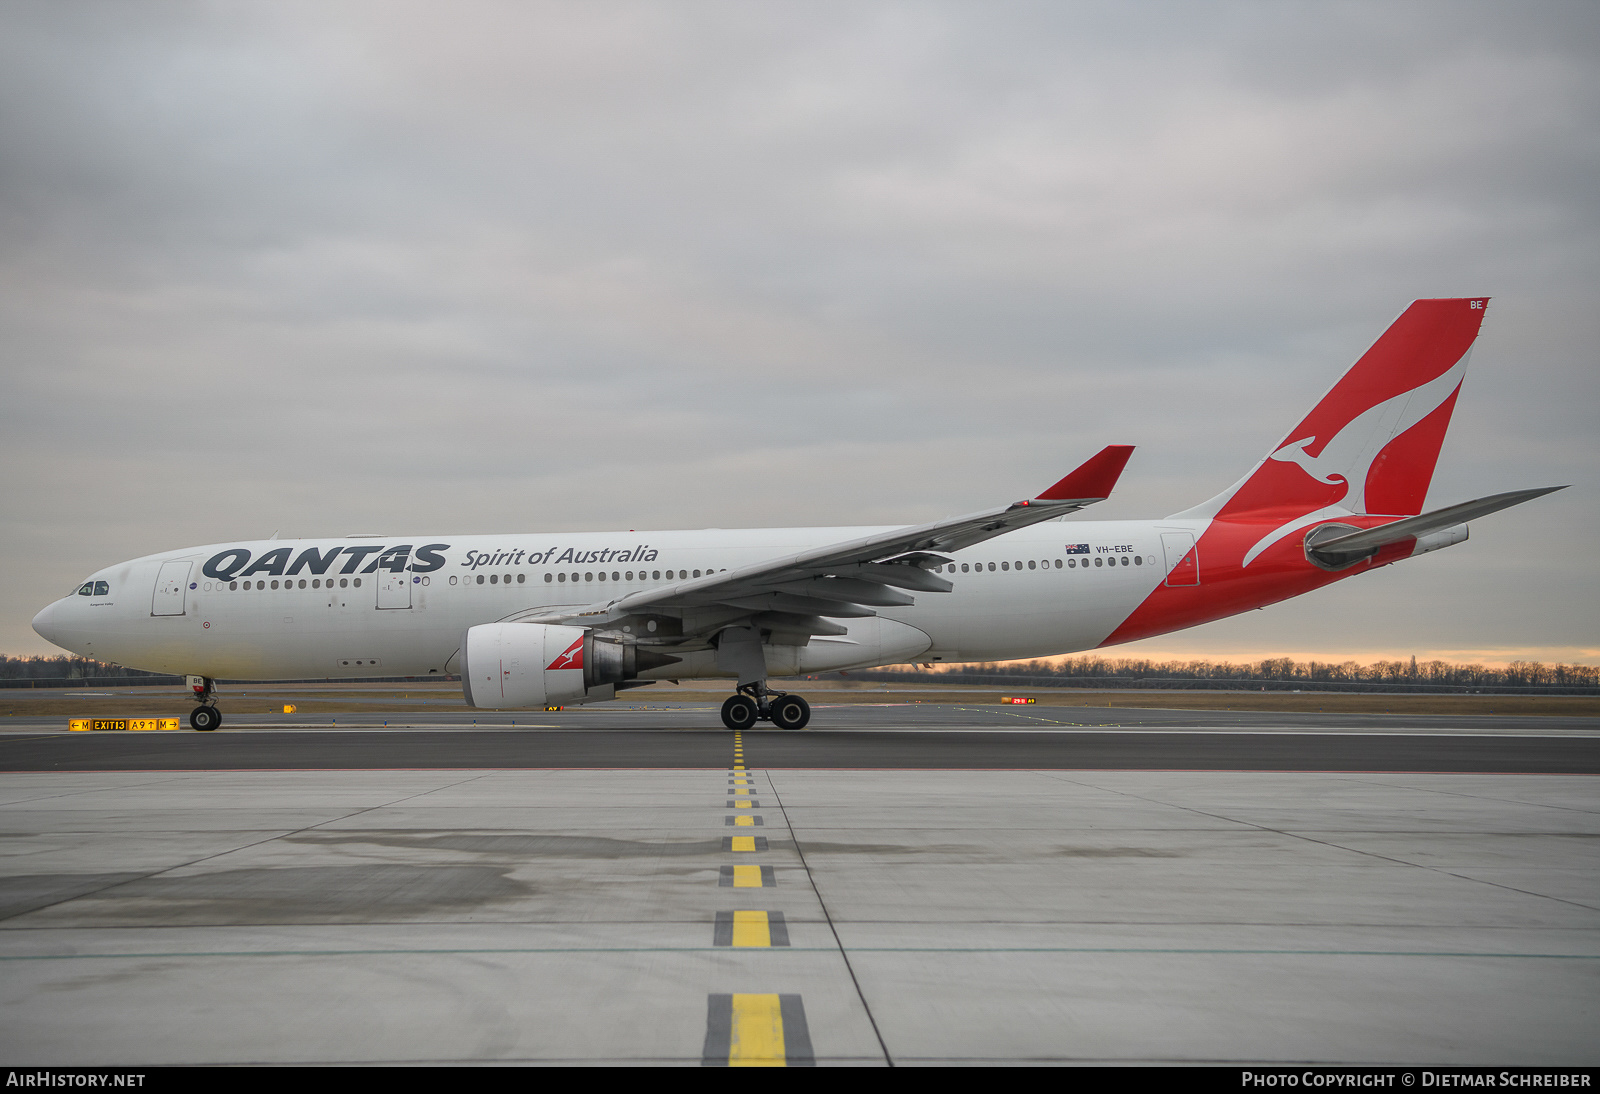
<box><xmin>34</xmin><ymin>299</ymin><xmax>1560</xmax><ymax>729</ymax></box>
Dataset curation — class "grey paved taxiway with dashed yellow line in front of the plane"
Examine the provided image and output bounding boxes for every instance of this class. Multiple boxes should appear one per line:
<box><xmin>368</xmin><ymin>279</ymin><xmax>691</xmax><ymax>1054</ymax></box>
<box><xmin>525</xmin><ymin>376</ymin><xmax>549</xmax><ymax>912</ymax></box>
<box><xmin>0</xmin><ymin>707</ymin><xmax>1600</xmax><ymax>1065</ymax></box>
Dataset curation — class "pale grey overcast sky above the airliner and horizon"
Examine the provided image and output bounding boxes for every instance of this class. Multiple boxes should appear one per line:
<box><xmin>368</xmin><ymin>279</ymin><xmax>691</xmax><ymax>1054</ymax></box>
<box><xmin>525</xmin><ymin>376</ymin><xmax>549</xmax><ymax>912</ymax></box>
<box><xmin>0</xmin><ymin>0</ymin><xmax>1600</xmax><ymax>664</ymax></box>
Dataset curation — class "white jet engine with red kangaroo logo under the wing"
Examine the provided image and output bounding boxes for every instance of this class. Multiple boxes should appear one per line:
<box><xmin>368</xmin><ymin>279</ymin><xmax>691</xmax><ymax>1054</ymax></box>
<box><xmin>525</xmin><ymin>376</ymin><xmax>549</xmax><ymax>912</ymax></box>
<box><xmin>461</xmin><ymin>622</ymin><xmax>678</xmax><ymax>710</ymax></box>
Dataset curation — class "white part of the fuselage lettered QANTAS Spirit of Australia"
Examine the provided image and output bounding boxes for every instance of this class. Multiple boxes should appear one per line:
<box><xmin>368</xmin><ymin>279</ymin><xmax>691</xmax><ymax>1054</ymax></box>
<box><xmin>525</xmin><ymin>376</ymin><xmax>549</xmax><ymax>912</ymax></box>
<box><xmin>34</xmin><ymin>520</ymin><xmax>1206</xmax><ymax>680</ymax></box>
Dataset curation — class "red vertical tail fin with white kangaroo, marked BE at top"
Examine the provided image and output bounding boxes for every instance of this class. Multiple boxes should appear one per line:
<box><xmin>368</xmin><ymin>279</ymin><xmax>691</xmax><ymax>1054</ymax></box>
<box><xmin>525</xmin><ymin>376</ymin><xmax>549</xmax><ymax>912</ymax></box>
<box><xmin>1178</xmin><ymin>297</ymin><xmax>1488</xmax><ymax>518</ymax></box>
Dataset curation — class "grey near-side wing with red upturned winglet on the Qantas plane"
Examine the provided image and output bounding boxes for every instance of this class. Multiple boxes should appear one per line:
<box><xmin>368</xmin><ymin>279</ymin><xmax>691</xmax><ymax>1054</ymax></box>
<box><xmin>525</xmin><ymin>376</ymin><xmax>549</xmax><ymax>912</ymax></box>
<box><xmin>512</xmin><ymin>445</ymin><xmax>1133</xmax><ymax>649</ymax></box>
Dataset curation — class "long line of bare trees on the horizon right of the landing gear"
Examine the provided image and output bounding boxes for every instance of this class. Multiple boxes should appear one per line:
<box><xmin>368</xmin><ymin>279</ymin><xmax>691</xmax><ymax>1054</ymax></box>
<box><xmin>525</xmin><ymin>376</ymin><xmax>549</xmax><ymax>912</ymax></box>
<box><xmin>848</xmin><ymin>656</ymin><xmax>1600</xmax><ymax>694</ymax></box>
